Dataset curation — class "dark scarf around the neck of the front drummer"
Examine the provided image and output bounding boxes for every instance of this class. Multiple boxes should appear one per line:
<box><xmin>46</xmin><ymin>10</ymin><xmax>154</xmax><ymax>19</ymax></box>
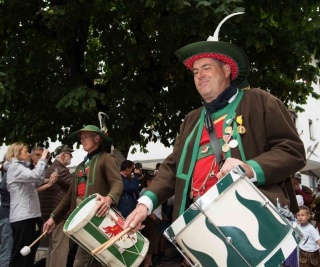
<box><xmin>203</xmin><ymin>83</ymin><xmax>237</xmax><ymax>114</ymax></box>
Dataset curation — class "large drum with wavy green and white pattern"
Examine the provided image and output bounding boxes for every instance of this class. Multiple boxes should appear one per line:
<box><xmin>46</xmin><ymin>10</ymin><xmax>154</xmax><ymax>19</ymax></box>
<box><xmin>165</xmin><ymin>168</ymin><xmax>298</xmax><ymax>267</ymax></box>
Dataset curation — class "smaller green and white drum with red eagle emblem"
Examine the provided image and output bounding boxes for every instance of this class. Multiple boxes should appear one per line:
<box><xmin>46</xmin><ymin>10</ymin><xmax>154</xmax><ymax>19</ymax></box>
<box><xmin>63</xmin><ymin>194</ymin><xmax>149</xmax><ymax>267</ymax></box>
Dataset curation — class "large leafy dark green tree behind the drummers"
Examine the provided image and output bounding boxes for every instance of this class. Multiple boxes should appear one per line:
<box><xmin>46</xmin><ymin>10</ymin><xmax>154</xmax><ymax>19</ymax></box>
<box><xmin>0</xmin><ymin>0</ymin><xmax>319</xmax><ymax>158</ymax></box>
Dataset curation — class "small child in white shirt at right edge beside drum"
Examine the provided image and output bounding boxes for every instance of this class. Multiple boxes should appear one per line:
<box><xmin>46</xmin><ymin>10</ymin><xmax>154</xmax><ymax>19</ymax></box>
<box><xmin>297</xmin><ymin>205</ymin><xmax>320</xmax><ymax>267</ymax></box>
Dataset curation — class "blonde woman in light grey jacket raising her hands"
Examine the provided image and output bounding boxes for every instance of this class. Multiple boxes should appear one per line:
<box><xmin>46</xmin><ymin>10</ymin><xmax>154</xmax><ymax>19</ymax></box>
<box><xmin>5</xmin><ymin>143</ymin><xmax>56</xmax><ymax>267</ymax></box>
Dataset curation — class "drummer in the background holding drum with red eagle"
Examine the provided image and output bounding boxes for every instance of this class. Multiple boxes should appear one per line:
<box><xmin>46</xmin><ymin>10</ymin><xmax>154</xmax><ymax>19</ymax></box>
<box><xmin>43</xmin><ymin>125</ymin><xmax>123</xmax><ymax>267</ymax></box>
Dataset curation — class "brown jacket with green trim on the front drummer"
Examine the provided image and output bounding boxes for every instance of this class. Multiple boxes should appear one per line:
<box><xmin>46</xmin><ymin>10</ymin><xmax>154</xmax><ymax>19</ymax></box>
<box><xmin>144</xmin><ymin>88</ymin><xmax>306</xmax><ymax>219</ymax></box>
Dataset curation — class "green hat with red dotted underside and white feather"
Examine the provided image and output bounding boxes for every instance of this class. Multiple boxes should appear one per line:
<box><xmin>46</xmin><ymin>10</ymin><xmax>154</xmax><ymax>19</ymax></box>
<box><xmin>175</xmin><ymin>12</ymin><xmax>250</xmax><ymax>84</ymax></box>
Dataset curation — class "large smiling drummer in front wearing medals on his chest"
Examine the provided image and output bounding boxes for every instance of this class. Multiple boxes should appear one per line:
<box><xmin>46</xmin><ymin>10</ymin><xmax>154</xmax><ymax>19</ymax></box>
<box><xmin>125</xmin><ymin>14</ymin><xmax>306</xmax><ymax>234</ymax></box>
